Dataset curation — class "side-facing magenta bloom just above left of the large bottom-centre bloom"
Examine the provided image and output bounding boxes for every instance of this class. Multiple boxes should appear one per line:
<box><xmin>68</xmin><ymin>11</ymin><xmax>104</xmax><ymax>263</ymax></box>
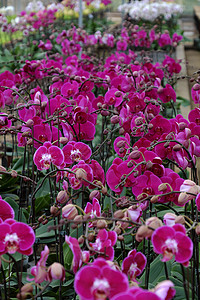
<box><xmin>65</xmin><ymin>235</ymin><xmax>90</xmax><ymax>273</ymax></box>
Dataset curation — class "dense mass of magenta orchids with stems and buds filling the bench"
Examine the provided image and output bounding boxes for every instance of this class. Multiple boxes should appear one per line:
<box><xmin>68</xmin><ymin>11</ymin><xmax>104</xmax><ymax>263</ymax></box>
<box><xmin>0</xmin><ymin>1</ymin><xmax>200</xmax><ymax>300</ymax></box>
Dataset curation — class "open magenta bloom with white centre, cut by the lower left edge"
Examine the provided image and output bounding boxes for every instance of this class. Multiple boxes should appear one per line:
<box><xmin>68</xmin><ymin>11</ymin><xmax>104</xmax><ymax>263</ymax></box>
<box><xmin>0</xmin><ymin>219</ymin><xmax>35</xmax><ymax>255</ymax></box>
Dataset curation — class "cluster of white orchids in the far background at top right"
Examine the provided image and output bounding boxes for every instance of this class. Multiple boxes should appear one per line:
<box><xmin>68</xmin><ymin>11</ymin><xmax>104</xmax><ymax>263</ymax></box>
<box><xmin>118</xmin><ymin>0</ymin><xmax>183</xmax><ymax>22</ymax></box>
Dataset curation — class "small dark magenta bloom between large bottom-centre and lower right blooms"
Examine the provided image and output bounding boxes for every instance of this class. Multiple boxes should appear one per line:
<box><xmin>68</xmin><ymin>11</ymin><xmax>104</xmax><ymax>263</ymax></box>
<box><xmin>122</xmin><ymin>249</ymin><xmax>147</xmax><ymax>281</ymax></box>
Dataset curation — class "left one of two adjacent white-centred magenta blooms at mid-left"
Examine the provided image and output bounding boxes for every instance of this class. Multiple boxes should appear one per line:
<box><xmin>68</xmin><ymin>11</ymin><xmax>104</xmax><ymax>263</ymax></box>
<box><xmin>33</xmin><ymin>142</ymin><xmax>64</xmax><ymax>170</ymax></box>
